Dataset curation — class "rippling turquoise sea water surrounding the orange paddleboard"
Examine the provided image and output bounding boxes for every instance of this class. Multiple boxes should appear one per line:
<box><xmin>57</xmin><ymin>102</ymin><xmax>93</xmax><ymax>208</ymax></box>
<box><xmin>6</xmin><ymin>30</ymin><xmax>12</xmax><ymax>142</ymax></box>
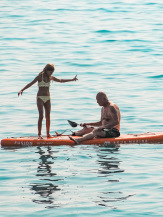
<box><xmin>0</xmin><ymin>0</ymin><xmax>163</xmax><ymax>217</ymax></box>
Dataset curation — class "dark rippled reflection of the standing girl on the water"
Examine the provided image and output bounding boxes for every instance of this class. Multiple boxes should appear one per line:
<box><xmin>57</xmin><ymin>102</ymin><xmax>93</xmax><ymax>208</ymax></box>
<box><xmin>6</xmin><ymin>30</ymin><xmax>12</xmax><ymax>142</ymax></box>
<box><xmin>30</xmin><ymin>147</ymin><xmax>60</xmax><ymax>207</ymax></box>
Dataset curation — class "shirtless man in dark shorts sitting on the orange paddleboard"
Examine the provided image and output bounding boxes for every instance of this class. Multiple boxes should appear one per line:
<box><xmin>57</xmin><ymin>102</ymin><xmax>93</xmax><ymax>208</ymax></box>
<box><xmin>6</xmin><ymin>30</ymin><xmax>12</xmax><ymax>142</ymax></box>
<box><xmin>69</xmin><ymin>92</ymin><xmax>121</xmax><ymax>144</ymax></box>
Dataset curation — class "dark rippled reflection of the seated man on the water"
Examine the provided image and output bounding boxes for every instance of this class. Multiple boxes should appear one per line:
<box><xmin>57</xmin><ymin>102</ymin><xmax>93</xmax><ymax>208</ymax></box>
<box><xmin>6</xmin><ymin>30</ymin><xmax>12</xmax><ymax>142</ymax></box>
<box><xmin>97</xmin><ymin>147</ymin><xmax>133</xmax><ymax>209</ymax></box>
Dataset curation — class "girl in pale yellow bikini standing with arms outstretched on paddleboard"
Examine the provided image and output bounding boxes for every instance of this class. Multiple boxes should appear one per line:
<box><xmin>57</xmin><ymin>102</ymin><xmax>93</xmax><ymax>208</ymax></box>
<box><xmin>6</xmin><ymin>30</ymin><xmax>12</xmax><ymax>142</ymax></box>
<box><xmin>18</xmin><ymin>63</ymin><xmax>78</xmax><ymax>139</ymax></box>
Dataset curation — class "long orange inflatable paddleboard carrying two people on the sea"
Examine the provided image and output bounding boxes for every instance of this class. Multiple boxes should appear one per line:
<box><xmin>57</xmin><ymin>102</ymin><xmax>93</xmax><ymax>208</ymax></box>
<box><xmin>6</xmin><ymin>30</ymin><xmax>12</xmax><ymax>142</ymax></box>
<box><xmin>1</xmin><ymin>132</ymin><xmax>163</xmax><ymax>147</ymax></box>
